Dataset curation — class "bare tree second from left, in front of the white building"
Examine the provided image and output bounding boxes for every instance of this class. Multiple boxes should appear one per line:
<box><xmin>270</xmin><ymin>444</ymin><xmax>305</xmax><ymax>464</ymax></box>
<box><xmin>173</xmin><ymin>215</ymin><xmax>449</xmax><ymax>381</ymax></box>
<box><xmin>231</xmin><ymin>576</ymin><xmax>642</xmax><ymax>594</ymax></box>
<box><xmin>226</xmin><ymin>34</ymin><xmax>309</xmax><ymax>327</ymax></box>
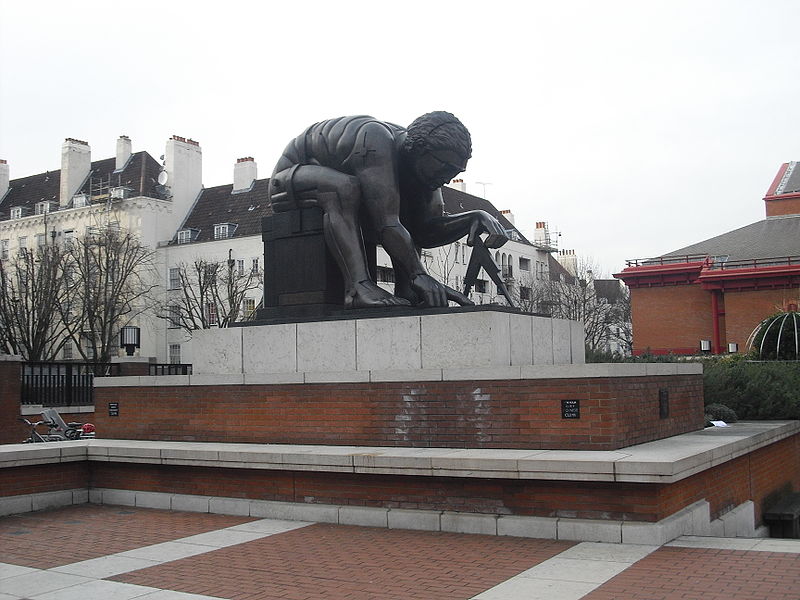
<box><xmin>60</xmin><ymin>227</ymin><xmax>158</xmax><ymax>362</ymax></box>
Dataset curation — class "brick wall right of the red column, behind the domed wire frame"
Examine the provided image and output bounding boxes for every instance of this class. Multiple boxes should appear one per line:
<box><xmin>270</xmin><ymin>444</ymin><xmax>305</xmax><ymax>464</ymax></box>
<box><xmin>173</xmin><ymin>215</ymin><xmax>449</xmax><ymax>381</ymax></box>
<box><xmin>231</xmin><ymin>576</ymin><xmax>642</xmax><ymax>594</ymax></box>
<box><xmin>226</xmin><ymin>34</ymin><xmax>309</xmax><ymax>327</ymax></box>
<box><xmin>725</xmin><ymin>288</ymin><xmax>800</xmax><ymax>352</ymax></box>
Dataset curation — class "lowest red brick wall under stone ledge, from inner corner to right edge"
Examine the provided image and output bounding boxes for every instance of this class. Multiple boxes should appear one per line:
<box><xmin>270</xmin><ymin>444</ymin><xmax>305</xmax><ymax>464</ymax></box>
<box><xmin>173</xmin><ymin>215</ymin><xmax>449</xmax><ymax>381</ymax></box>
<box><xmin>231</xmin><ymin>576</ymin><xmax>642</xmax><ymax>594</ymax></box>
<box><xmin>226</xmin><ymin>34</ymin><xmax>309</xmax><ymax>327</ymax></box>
<box><xmin>91</xmin><ymin>435</ymin><xmax>800</xmax><ymax>522</ymax></box>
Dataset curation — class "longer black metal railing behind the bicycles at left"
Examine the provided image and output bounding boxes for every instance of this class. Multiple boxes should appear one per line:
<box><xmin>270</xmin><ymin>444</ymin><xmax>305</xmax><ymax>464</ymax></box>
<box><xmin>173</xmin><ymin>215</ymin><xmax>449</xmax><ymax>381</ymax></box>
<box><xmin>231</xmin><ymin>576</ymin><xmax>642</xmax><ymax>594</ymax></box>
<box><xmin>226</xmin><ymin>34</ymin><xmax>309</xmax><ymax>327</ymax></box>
<box><xmin>20</xmin><ymin>362</ymin><xmax>119</xmax><ymax>406</ymax></box>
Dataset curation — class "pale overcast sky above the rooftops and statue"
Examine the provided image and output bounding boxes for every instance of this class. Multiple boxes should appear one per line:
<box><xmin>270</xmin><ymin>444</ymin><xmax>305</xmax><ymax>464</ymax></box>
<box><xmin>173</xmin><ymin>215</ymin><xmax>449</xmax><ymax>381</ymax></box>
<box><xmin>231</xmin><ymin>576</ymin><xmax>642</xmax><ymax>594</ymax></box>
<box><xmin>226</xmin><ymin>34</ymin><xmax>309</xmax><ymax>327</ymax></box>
<box><xmin>0</xmin><ymin>0</ymin><xmax>800</xmax><ymax>274</ymax></box>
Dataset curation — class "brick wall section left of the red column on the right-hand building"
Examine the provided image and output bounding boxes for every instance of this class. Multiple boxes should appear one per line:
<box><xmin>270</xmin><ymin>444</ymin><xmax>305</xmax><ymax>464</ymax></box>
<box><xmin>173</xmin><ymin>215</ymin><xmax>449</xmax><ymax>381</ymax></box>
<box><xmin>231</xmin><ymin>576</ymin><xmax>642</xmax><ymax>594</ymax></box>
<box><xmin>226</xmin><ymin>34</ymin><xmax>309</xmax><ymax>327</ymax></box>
<box><xmin>631</xmin><ymin>285</ymin><xmax>712</xmax><ymax>354</ymax></box>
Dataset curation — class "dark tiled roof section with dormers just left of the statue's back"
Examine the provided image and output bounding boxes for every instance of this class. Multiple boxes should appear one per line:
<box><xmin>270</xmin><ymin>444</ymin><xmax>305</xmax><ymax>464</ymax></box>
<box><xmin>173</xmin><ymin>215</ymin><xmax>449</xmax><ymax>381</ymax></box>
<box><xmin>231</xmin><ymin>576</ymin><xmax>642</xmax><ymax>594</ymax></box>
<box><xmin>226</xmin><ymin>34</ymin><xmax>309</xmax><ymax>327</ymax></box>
<box><xmin>175</xmin><ymin>179</ymin><xmax>272</xmax><ymax>242</ymax></box>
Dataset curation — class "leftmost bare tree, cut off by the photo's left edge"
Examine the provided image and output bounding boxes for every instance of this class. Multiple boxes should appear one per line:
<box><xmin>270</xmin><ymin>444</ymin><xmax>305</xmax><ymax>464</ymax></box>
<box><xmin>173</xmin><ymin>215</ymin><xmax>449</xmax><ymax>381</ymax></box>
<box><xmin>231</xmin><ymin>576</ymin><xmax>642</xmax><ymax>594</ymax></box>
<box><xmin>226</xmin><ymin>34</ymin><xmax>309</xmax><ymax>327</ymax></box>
<box><xmin>0</xmin><ymin>244</ymin><xmax>67</xmax><ymax>361</ymax></box>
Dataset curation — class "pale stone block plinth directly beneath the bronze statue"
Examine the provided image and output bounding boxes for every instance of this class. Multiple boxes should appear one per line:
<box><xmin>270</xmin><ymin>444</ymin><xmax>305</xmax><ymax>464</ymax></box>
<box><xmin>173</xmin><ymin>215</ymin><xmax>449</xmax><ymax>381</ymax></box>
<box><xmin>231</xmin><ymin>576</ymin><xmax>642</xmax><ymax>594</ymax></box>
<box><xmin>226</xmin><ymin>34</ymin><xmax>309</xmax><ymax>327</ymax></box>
<box><xmin>182</xmin><ymin>310</ymin><xmax>585</xmax><ymax>374</ymax></box>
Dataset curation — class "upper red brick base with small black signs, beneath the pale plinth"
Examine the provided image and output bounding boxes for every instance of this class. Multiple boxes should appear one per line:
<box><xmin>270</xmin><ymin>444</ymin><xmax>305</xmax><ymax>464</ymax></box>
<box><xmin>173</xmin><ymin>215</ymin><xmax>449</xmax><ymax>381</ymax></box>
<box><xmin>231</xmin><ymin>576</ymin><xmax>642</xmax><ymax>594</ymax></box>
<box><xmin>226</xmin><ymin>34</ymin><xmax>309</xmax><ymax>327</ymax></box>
<box><xmin>94</xmin><ymin>375</ymin><xmax>703</xmax><ymax>450</ymax></box>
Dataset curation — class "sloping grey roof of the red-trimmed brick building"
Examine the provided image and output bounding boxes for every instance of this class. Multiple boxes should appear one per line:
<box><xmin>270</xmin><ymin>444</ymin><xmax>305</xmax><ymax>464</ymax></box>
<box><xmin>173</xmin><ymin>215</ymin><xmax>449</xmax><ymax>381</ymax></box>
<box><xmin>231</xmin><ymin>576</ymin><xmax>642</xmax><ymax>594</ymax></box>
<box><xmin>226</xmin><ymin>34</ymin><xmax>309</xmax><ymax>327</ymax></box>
<box><xmin>663</xmin><ymin>215</ymin><xmax>800</xmax><ymax>261</ymax></box>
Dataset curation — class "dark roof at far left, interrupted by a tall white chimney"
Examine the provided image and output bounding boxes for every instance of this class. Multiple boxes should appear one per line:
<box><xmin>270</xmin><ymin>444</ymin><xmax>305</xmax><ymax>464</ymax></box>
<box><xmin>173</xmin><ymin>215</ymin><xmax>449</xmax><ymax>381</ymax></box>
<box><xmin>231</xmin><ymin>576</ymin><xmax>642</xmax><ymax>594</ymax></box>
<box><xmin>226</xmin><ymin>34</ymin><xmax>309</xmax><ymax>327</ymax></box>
<box><xmin>0</xmin><ymin>151</ymin><xmax>161</xmax><ymax>220</ymax></box>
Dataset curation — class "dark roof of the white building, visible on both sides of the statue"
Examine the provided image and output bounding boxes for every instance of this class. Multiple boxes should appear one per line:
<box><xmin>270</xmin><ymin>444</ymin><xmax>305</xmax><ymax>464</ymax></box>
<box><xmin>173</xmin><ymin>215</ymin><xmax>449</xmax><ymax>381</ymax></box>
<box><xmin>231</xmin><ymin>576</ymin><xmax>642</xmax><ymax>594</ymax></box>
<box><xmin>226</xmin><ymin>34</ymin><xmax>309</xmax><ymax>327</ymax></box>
<box><xmin>171</xmin><ymin>179</ymin><xmax>530</xmax><ymax>244</ymax></box>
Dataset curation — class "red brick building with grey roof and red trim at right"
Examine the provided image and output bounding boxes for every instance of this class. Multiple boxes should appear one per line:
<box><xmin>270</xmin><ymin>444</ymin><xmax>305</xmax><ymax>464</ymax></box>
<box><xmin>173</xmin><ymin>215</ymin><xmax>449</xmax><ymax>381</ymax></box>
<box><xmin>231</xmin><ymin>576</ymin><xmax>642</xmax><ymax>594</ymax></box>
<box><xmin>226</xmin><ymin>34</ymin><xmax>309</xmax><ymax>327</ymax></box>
<box><xmin>614</xmin><ymin>162</ymin><xmax>800</xmax><ymax>354</ymax></box>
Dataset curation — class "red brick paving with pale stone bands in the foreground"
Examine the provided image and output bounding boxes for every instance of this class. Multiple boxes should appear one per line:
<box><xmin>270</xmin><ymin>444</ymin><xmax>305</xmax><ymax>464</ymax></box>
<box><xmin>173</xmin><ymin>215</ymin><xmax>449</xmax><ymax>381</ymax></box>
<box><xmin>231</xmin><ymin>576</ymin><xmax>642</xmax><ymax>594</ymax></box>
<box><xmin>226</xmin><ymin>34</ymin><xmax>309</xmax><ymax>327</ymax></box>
<box><xmin>0</xmin><ymin>505</ymin><xmax>800</xmax><ymax>600</ymax></box>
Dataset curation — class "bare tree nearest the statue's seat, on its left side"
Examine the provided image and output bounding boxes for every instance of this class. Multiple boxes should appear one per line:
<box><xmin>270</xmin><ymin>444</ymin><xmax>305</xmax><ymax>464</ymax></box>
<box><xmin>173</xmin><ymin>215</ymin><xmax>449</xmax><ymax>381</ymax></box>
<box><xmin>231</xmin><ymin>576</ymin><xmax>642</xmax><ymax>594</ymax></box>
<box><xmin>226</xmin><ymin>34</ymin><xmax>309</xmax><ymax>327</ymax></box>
<box><xmin>158</xmin><ymin>259</ymin><xmax>263</xmax><ymax>331</ymax></box>
